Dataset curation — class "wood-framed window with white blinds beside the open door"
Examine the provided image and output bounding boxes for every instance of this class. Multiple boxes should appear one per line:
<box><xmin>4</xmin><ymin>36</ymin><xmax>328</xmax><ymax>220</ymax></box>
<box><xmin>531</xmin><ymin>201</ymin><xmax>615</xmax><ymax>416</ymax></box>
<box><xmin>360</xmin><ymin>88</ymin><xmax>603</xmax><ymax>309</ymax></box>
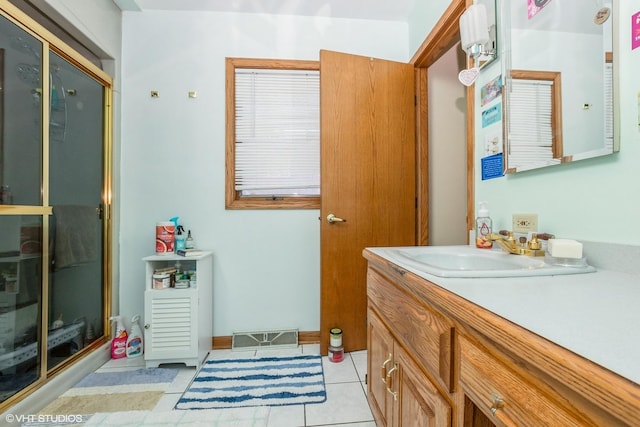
<box><xmin>227</xmin><ymin>59</ymin><xmax>320</xmax><ymax>208</ymax></box>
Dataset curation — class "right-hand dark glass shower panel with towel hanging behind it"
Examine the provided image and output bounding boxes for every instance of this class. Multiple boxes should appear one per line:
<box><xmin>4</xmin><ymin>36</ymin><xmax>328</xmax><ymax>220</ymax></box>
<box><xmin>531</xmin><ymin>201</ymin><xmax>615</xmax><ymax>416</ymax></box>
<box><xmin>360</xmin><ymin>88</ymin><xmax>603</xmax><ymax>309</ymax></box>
<box><xmin>47</xmin><ymin>52</ymin><xmax>104</xmax><ymax>369</ymax></box>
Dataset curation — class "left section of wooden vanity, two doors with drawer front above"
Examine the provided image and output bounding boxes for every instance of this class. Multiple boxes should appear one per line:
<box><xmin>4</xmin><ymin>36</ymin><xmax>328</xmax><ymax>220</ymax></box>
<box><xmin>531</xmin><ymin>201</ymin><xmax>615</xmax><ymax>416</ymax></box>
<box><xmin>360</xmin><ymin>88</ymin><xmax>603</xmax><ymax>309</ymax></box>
<box><xmin>367</xmin><ymin>270</ymin><xmax>451</xmax><ymax>427</ymax></box>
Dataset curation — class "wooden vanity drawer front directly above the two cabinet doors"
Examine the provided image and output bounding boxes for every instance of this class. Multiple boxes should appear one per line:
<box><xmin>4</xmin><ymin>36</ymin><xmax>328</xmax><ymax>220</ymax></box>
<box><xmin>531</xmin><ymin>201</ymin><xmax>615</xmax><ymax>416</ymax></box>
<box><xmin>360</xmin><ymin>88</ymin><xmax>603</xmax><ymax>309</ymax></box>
<box><xmin>367</xmin><ymin>268</ymin><xmax>454</xmax><ymax>392</ymax></box>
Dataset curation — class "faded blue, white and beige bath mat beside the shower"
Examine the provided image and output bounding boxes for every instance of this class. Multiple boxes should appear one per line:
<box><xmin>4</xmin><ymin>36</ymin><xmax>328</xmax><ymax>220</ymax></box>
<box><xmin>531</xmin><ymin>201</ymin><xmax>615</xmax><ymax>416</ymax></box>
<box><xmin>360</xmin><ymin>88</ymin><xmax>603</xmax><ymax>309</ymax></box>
<box><xmin>40</xmin><ymin>368</ymin><xmax>178</xmax><ymax>415</ymax></box>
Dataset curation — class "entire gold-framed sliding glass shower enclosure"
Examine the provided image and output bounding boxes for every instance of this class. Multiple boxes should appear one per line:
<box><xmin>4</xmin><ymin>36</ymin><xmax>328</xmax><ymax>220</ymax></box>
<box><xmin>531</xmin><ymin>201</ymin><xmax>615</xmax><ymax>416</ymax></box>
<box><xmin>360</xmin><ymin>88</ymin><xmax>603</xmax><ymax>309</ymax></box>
<box><xmin>0</xmin><ymin>5</ymin><xmax>111</xmax><ymax>410</ymax></box>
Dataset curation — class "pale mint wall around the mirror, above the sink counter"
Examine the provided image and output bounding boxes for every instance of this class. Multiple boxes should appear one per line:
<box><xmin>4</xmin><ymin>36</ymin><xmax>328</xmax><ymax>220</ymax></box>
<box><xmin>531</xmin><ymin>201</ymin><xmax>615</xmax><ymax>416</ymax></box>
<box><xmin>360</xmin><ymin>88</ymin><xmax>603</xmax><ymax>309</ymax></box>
<box><xmin>475</xmin><ymin>0</ymin><xmax>640</xmax><ymax>245</ymax></box>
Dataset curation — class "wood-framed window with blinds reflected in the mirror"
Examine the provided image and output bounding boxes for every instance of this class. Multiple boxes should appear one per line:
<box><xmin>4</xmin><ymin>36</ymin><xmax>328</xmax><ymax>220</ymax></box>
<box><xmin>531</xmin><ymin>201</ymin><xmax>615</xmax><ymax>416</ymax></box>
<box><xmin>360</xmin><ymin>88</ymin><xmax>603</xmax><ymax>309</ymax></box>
<box><xmin>508</xmin><ymin>70</ymin><xmax>562</xmax><ymax>170</ymax></box>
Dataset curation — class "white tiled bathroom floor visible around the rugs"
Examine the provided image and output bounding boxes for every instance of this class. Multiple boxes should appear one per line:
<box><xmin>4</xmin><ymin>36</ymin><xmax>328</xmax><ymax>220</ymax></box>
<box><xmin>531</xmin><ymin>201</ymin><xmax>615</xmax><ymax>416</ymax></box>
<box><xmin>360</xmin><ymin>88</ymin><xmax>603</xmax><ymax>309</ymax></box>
<box><xmin>97</xmin><ymin>344</ymin><xmax>376</xmax><ymax>427</ymax></box>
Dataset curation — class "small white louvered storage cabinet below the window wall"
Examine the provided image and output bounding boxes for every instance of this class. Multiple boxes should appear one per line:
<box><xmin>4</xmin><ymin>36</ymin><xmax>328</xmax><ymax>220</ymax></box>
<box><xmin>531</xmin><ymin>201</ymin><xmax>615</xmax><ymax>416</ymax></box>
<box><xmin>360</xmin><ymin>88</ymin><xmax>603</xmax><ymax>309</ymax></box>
<box><xmin>143</xmin><ymin>251</ymin><xmax>213</xmax><ymax>368</ymax></box>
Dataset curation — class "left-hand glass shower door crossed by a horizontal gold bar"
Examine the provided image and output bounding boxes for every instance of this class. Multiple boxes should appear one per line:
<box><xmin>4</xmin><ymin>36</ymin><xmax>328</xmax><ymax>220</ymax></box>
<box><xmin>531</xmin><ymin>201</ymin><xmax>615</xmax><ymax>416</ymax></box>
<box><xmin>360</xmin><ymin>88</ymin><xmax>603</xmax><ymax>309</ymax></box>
<box><xmin>0</xmin><ymin>16</ymin><xmax>47</xmax><ymax>403</ymax></box>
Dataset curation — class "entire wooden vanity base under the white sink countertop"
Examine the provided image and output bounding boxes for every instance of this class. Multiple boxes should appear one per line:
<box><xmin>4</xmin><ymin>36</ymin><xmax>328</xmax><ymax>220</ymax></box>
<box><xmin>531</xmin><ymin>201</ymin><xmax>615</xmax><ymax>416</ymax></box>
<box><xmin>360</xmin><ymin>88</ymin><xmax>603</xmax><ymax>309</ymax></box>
<box><xmin>364</xmin><ymin>250</ymin><xmax>640</xmax><ymax>427</ymax></box>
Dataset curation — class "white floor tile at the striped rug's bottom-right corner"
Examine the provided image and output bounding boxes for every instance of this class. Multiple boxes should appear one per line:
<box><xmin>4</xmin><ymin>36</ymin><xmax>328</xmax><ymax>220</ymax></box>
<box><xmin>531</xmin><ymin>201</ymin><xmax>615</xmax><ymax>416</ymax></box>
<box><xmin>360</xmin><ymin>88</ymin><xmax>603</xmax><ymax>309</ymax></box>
<box><xmin>305</xmin><ymin>382</ymin><xmax>373</xmax><ymax>426</ymax></box>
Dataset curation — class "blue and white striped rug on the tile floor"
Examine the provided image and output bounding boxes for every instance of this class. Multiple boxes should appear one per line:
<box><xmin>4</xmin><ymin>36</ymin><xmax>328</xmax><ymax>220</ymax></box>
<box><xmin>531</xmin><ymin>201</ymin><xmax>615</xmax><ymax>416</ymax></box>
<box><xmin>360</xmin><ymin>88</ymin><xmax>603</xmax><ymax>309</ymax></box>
<box><xmin>176</xmin><ymin>354</ymin><xmax>327</xmax><ymax>409</ymax></box>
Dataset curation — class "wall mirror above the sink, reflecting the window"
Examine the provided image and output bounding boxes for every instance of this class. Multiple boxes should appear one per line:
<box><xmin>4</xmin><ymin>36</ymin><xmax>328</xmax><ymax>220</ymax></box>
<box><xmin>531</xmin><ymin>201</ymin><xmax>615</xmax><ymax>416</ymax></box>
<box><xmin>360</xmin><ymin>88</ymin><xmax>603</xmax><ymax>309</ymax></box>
<box><xmin>500</xmin><ymin>0</ymin><xmax>618</xmax><ymax>173</ymax></box>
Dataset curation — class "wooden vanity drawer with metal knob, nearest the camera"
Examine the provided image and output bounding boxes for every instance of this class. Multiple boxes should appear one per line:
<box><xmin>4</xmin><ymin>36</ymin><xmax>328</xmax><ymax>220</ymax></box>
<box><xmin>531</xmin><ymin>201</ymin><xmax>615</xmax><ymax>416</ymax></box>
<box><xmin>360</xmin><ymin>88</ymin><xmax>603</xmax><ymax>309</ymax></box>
<box><xmin>459</xmin><ymin>336</ymin><xmax>589</xmax><ymax>427</ymax></box>
